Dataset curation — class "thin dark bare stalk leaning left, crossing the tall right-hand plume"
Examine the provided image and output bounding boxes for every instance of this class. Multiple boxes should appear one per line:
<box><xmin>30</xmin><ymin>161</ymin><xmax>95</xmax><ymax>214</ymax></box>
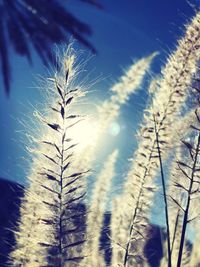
<box><xmin>154</xmin><ymin>118</ymin><xmax>172</xmax><ymax>267</ymax></box>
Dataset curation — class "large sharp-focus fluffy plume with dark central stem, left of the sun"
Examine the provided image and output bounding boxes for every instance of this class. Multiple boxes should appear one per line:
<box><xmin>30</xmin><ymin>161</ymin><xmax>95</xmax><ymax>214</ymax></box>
<box><xmin>11</xmin><ymin>47</ymin><xmax>90</xmax><ymax>267</ymax></box>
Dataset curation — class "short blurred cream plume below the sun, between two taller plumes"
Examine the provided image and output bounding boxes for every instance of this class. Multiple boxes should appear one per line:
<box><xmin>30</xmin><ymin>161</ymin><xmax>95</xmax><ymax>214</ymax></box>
<box><xmin>82</xmin><ymin>150</ymin><xmax>118</xmax><ymax>267</ymax></box>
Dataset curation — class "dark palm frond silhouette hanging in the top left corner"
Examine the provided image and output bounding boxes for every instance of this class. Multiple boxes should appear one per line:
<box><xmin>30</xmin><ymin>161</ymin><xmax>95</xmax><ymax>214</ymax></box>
<box><xmin>0</xmin><ymin>0</ymin><xmax>98</xmax><ymax>95</ymax></box>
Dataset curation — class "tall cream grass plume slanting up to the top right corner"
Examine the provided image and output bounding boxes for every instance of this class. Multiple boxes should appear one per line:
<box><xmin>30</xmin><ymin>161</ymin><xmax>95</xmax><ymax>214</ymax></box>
<box><xmin>110</xmin><ymin>11</ymin><xmax>200</xmax><ymax>266</ymax></box>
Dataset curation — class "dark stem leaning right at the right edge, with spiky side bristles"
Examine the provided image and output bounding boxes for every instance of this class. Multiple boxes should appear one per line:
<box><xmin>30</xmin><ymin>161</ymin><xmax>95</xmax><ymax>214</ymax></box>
<box><xmin>177</xmin><ymin>133</ymin><xmax>200</xmax><ymax>267</ymax></box>
